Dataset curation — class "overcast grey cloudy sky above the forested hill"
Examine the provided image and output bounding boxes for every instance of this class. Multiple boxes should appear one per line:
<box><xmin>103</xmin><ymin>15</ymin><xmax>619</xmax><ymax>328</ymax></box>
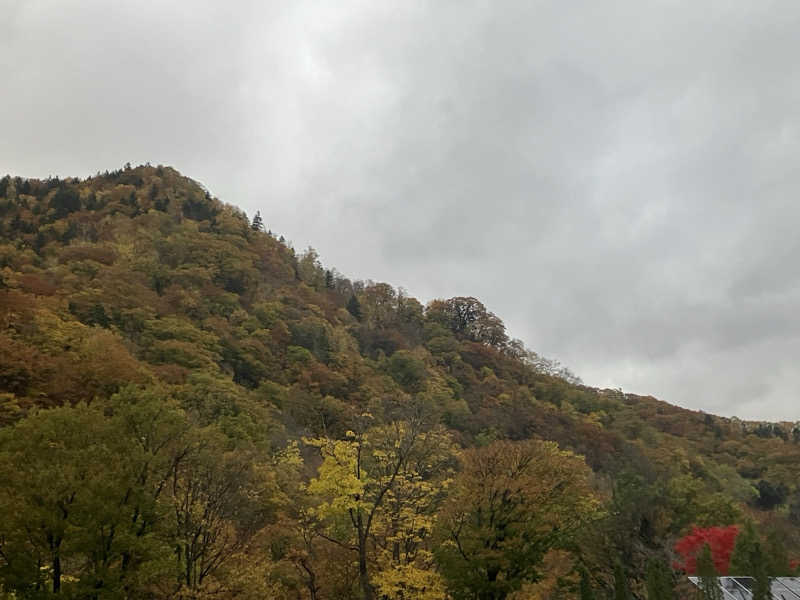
<box><xmin>0</xmin><ymin>0</ymin><xmax>800</xmax><ymax>420</ymax></box>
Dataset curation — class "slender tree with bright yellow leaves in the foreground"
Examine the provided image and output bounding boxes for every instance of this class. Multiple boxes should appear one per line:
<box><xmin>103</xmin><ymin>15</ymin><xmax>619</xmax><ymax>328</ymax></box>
<box><xmin>306</xmin><ymin>417</ymin><xmax>455</xmax><ymax>600</ymax></box>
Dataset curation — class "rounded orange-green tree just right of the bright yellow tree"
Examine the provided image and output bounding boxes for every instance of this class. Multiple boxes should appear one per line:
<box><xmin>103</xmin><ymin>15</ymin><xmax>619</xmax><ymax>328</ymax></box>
<box><xmin>437</xmin><ymin>440</ymin><xmax>599</xmax><ymax>600</ymax></box>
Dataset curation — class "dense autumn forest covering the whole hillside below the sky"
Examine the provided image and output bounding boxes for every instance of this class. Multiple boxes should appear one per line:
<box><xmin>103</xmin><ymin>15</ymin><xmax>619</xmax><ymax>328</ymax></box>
<box><xmin>0</xmin><ymin>165</ymin><xmax>800</xmax><ymax>600</ymax></box>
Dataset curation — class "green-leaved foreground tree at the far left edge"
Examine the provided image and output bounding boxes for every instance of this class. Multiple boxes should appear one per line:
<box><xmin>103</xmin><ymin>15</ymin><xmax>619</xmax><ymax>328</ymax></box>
<box><xmin>0</xmin><ymin>405</ymin><xmax>108</xmax><ymax>595</ymax></box>
